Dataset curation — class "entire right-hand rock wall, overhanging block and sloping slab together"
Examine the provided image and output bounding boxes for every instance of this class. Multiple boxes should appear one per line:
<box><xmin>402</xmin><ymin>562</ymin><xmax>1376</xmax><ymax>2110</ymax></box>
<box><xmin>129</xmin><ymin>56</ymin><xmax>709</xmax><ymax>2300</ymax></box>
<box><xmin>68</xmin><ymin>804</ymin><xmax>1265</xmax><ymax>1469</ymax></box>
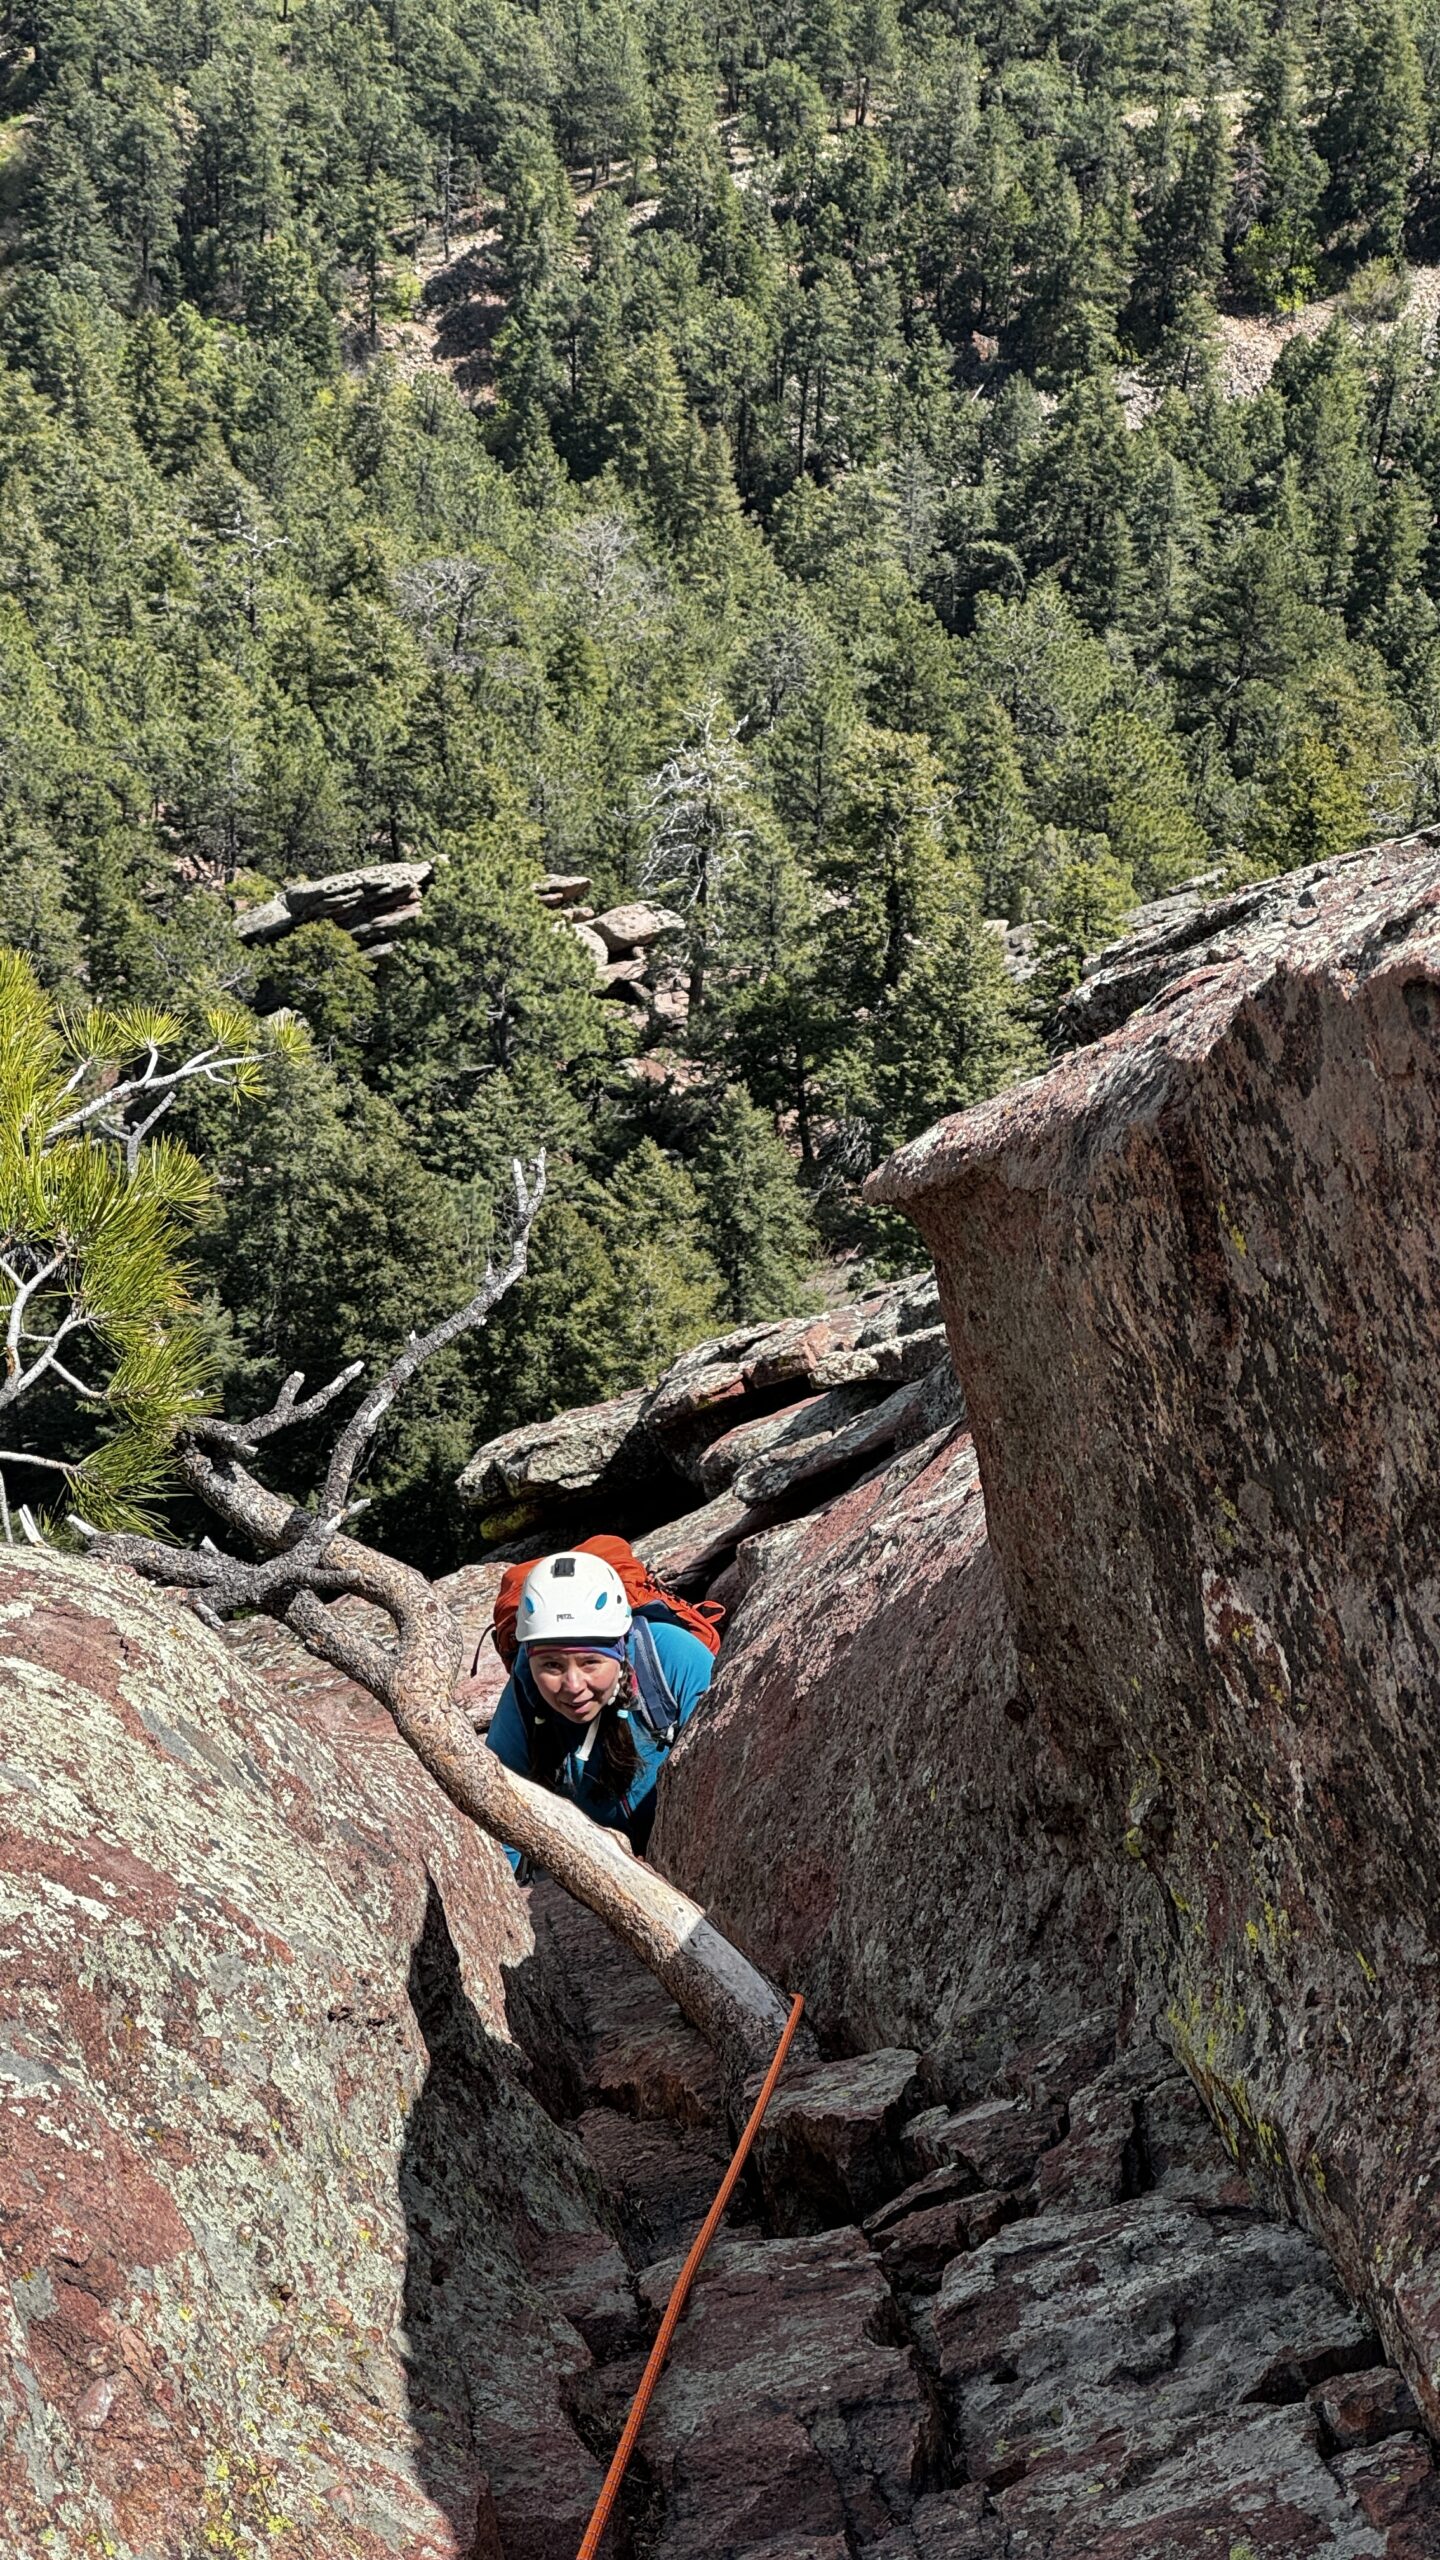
<box><xmin>656</xmin><ymin>835</ymin><xmax>1440</xmax><ymax>2447</ymax></box>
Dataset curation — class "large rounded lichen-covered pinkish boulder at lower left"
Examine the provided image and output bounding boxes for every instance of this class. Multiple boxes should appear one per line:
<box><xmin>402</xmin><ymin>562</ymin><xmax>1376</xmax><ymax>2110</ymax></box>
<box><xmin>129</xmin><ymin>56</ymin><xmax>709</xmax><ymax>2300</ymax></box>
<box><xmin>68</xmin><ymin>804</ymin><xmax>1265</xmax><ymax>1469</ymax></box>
<box><xmin>0</xmin><ymin>1549</ymin><xmax>612</xmax><ymax>2560</ymax></box>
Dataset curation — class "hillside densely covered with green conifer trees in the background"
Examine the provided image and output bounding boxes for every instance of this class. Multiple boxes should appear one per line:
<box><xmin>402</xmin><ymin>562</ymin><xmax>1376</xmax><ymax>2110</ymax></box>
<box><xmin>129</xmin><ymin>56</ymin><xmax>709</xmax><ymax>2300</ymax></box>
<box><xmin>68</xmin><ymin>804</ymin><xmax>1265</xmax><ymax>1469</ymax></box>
<box><xmin>0</xmin><ymin>0</ymin><xmax>1440</xmax><ymax>1559</ymax></box>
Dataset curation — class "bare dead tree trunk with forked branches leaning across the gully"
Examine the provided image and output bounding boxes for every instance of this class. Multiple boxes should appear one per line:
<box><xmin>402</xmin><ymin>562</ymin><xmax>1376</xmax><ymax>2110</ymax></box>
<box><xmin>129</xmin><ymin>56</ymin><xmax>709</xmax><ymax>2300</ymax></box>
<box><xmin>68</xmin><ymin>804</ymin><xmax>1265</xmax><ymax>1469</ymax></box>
<box><xmin>74</xmin><ymin>1157</ymin><xmax>787</xmax><ymax>2076</ymax></box>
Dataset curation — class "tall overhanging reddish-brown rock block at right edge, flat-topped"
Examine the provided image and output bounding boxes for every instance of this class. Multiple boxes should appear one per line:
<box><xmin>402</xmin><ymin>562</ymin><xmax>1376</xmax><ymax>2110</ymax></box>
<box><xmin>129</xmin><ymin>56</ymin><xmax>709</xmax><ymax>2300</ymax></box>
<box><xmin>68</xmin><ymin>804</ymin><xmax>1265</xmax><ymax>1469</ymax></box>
<box><xmin>874</xmin><ymin>835</ymin><xmax>1440</xmax><ymax>2422</ymax></box>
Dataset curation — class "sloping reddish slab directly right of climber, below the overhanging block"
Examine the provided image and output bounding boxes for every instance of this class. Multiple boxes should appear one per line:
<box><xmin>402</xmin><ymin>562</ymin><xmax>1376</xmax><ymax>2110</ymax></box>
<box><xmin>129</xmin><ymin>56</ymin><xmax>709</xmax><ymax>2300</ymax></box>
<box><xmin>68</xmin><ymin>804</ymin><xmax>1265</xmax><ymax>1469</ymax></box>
<box><xmin>653</xmin><ymin>1426</ymin><xmax>1122</xmax><ymax>2068</ymax></box>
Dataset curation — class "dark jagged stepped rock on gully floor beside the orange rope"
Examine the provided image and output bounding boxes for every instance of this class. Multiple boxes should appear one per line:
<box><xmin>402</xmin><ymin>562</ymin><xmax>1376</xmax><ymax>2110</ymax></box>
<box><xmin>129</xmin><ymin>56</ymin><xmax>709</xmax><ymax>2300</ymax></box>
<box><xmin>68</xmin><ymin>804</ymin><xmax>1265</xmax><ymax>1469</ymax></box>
<box><xmin>509</xmin><ymin>1887</ymin><xmax>1440</xmax><ymax>2560</ymax></box>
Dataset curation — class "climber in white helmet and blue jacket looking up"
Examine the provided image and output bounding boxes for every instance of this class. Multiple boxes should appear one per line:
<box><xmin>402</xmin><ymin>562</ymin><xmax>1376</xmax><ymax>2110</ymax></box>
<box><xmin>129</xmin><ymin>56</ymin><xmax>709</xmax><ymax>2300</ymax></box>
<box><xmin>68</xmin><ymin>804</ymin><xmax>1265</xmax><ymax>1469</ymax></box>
<box><xmin>487</xmin><ymin>1551</ymin><xmax>715</xmax><ymax>1871</ymax></box>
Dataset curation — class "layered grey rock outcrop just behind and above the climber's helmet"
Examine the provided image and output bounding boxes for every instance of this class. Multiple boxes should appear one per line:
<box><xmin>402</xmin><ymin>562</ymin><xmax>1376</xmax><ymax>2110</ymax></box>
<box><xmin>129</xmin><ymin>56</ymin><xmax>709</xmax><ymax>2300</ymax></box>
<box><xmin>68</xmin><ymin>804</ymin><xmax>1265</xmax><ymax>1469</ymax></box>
<box><xmin>459</xmin><ymin>1275</ymin><xmax>956</xmax><ymax>1556</ymax></box>
